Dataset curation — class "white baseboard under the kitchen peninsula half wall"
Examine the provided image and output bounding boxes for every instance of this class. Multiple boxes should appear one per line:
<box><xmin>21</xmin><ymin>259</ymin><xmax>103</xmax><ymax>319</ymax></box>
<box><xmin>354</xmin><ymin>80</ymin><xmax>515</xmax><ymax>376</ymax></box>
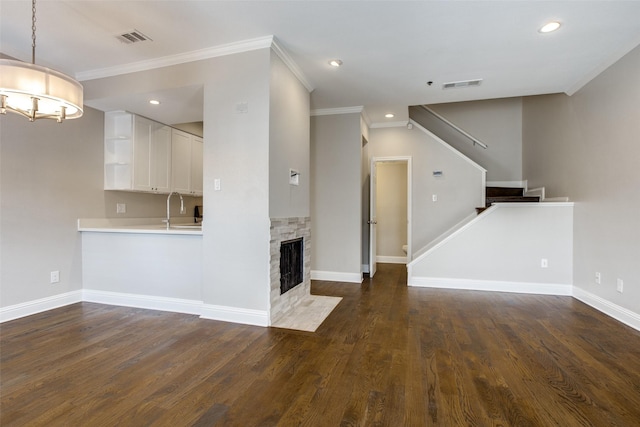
<box><xmin>82</xmin><ymin>289</ymin><xmax>202</xmax><ymax>315</ymax></box>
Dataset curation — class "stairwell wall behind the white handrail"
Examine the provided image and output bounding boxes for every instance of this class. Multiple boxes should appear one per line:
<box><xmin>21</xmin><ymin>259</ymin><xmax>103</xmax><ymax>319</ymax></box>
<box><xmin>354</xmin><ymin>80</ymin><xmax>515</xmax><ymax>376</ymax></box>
<box><xmin>412</xmin><ymin>98</ymin><xmax>527</xmax><ymax>181</ymax></box>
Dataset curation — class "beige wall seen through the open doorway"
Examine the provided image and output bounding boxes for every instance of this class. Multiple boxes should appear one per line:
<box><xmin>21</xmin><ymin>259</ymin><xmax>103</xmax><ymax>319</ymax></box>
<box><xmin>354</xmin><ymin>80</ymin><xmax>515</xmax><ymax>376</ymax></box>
<box><xmin>376</xmin><ymin>162</ymin><xmax>407</xmax><ymax>257</ymax></box>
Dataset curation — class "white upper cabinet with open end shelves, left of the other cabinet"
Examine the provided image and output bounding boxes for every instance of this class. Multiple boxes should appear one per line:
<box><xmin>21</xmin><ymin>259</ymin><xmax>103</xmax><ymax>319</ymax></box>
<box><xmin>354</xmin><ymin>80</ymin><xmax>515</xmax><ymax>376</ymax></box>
<box><xmin>104</xmin><ymin>111</ymin><xmax>171</xmax><ymax>193</ymax></box>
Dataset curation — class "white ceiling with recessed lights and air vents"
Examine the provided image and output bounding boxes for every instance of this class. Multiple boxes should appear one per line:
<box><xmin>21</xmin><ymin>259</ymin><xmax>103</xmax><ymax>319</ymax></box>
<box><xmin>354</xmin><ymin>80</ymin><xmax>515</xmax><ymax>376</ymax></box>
<box><xmin>0</xmin><ymin>0</ymin><xmax>640</xmax><ymax>123</ymax></box>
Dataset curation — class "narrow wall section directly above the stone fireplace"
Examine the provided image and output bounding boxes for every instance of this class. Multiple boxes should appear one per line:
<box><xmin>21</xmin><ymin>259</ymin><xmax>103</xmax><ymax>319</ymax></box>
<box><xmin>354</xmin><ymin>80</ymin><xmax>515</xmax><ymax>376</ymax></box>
<box><xmin>269</xmin><ymin>51</ymin><xmax>311</xmax><ymax>218</ymax></box>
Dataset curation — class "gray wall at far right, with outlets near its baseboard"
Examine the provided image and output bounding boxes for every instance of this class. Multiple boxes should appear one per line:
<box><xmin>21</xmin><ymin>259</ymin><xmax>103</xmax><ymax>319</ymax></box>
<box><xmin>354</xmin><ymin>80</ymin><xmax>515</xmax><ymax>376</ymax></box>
<box><xmin>523</xmin><ymin>47</ymin><xmax>640</xmax><ymax>313</ymax></box>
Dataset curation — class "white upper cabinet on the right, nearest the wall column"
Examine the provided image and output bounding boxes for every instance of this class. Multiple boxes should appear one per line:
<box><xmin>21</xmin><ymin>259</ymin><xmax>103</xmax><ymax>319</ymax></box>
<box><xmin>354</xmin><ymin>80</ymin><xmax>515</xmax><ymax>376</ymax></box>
<box><xmin>171</xmin><ymin>129</ymin><xmax>202</xmax><ymax>196</ymax></box>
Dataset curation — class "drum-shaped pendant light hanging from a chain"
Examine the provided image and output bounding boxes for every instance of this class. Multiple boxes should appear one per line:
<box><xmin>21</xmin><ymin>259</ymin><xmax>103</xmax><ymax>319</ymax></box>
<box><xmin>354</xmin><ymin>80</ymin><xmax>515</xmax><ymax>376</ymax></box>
<box><xmin>0</xmin><ymin>0</ymin><xmax>83</xmax><ymax>123</ymax></box>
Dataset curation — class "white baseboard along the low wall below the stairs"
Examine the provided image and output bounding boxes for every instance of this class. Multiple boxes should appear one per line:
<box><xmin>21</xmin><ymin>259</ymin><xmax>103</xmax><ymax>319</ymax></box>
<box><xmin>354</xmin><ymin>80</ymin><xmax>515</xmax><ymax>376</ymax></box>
<box><xmin>408</xmin><ymin>277</ymin><xmax>572</xmax><ymax>296</ymax></box>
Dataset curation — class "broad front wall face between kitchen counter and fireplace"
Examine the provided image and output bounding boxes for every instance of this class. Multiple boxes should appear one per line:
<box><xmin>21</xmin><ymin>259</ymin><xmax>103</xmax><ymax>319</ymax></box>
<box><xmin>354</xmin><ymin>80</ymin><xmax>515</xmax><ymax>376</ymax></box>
<box><xmin>202</xmin><ymin>49</ymin><xmax>271</xmax><ymax>311</ymax></box>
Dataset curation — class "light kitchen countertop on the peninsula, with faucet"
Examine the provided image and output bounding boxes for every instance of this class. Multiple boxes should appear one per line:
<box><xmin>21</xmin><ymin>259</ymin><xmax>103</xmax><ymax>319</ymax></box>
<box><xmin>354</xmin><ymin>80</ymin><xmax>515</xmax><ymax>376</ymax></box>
<box><xmin>78</xmin><ymin>217</ymin><xmax>202</xmax><ymax>236</ymax></box>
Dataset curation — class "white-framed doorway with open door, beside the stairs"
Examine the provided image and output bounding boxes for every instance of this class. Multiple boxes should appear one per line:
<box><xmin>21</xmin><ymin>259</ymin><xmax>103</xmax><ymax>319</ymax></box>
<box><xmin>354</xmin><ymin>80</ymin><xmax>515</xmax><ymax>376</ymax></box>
<box><xmin>368</xmin><ymin>157</ymin><xmax>412</xmax><ymax>277</ymax></box>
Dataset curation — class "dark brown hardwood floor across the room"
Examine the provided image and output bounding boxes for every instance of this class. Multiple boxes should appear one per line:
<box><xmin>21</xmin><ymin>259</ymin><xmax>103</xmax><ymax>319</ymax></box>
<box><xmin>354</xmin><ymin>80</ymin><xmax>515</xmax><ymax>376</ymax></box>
<box><xmin>0</xmin><ymin>264</ymin><xmax>640</xmax><ymax>427</ymax></box>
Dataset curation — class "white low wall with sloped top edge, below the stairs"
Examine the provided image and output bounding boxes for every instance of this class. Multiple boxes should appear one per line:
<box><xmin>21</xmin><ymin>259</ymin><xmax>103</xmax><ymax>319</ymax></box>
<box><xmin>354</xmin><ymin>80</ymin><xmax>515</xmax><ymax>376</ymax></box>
<box><xmin>410</xmin><ymin>203</ymin><xmax>573</xmax><ymax>294</ymax></box>
